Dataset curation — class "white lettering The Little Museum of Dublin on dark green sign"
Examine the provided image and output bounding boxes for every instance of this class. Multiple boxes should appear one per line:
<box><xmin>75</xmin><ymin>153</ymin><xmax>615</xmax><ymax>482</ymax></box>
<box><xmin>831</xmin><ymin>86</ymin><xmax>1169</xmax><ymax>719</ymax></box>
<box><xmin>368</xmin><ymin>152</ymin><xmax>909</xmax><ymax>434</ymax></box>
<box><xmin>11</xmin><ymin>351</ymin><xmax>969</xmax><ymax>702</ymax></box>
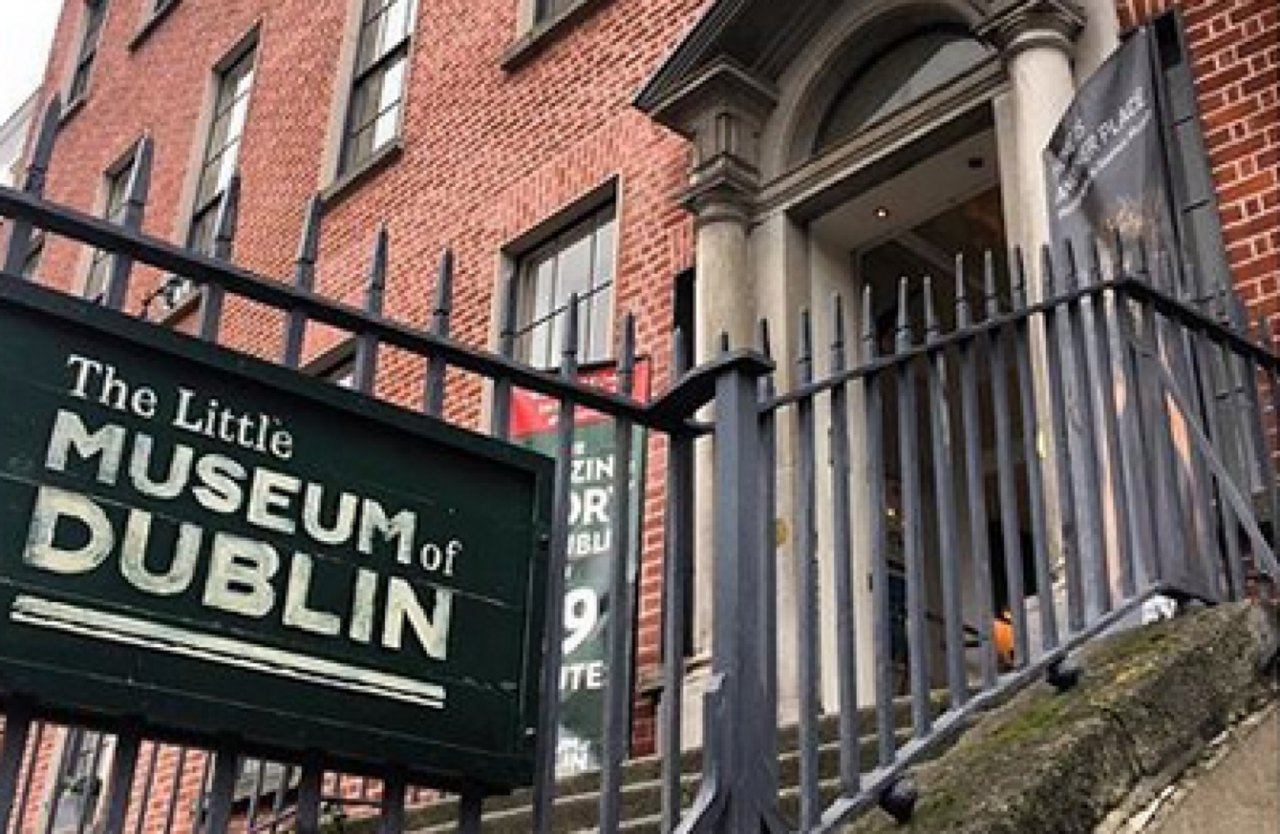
<box><xmin>16</xmin><ymin>354</ymin><xmax>476</xmax><ymax>661</ymax></box>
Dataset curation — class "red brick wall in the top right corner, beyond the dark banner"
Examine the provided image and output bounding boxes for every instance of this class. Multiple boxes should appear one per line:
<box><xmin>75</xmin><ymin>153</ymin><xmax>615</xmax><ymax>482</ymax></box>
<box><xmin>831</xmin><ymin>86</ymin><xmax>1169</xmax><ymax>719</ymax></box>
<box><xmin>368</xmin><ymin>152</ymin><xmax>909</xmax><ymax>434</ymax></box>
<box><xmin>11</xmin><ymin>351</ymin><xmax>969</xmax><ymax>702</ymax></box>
<box><xmin>1120</xmin><ymin>0</ymin><xmax>1280</xmax><ymax>316</ymax></box>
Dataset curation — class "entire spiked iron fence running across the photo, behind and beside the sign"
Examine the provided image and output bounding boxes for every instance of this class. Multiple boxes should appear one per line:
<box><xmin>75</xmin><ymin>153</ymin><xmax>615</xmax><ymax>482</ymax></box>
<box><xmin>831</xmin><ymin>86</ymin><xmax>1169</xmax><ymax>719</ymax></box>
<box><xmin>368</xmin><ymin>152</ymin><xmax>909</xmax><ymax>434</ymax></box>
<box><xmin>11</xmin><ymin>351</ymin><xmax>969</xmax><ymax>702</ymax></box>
<box><xmin>0</xmin><ymin>91</ymin><xmax>1280</xmax><ymax>833</ymax></box>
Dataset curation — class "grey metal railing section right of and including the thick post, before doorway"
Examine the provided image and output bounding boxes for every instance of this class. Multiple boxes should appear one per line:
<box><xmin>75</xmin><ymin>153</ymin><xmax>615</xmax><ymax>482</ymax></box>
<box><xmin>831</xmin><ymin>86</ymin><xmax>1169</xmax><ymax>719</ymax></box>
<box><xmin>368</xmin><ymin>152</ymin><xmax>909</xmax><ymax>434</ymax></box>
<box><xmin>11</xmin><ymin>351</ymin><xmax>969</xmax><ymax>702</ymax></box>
<box><xmin>664</xmin><ymin>239</ymin><xmax>1280</xmax><ymax>833</ymax></box>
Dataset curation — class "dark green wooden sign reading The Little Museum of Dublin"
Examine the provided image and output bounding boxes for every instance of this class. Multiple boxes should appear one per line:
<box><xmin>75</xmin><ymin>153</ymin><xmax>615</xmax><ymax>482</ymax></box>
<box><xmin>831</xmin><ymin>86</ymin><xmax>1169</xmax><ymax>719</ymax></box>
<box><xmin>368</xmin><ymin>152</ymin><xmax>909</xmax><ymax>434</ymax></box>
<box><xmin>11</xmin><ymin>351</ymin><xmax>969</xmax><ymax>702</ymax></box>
<box><xmin>0</xmin><ymin>279</ymin><xmax>552</xmax><ymax>788</ymax></box>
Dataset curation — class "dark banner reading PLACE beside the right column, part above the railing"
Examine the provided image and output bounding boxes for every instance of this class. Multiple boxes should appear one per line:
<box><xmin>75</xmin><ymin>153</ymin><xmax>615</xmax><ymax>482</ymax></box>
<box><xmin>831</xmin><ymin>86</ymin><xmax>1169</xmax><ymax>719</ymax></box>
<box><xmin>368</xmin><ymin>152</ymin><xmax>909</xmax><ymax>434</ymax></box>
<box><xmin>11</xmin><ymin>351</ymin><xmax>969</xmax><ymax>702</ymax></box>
<box><xmin>1044</xmin><ymin>28</ymin><xmax>1176</xmax><ymax>267</ymax></box>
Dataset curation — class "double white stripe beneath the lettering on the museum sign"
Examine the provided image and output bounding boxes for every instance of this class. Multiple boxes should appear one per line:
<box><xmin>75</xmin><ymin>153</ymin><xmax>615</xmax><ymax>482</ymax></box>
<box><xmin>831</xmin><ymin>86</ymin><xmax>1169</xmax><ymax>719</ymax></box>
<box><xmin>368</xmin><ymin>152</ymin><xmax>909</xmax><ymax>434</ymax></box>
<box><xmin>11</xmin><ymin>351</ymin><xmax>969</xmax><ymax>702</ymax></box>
<box><xmin>9</xmin><ymin>595</ymin><xmax>445</xmax><ymax>710</ymax></box>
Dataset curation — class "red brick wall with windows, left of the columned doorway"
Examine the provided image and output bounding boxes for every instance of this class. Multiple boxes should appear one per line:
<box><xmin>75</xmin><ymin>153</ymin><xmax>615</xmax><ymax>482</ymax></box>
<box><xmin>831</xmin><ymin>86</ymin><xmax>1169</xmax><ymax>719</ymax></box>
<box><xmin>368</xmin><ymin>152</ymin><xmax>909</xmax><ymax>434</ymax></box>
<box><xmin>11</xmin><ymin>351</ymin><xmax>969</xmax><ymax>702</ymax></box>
<box><xmin>24</xmin><ymin>0</ymin><xmax>701</xmax><ymax>777</ymax></box>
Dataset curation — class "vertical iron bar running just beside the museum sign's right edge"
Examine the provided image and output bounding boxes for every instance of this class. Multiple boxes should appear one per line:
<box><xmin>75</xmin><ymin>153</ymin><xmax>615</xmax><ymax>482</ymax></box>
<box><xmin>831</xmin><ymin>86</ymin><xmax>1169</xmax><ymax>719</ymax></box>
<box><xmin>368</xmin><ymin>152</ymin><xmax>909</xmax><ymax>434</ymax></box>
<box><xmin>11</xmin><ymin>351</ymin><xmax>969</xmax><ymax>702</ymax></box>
<box><xmin>534</xmin><ymin>293</ymin><xmax>579</xmax><ymax>834</ymax></box>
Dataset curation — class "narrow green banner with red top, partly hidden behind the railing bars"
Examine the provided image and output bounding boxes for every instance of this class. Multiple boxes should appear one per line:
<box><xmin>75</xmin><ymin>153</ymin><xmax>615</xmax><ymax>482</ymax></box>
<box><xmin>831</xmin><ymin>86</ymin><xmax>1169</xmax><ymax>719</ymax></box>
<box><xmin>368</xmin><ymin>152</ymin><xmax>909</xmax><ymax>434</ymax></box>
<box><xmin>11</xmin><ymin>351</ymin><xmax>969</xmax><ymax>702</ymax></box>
<box><xmin>512</xmin><ymin>361</ymin><xmax>649</xmax><ymax>775</ymax></box>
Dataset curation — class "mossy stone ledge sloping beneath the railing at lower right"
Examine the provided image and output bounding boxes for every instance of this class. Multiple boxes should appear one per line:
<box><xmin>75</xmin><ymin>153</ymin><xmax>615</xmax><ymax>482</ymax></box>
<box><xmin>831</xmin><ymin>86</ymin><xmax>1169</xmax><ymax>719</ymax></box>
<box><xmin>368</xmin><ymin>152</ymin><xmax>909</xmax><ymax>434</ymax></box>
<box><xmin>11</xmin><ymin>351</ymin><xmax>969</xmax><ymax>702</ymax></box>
<box><xmin>844</xmin><ymin>604</ymin><xmax>1277</xmax><ymax>834</ymax></box>
